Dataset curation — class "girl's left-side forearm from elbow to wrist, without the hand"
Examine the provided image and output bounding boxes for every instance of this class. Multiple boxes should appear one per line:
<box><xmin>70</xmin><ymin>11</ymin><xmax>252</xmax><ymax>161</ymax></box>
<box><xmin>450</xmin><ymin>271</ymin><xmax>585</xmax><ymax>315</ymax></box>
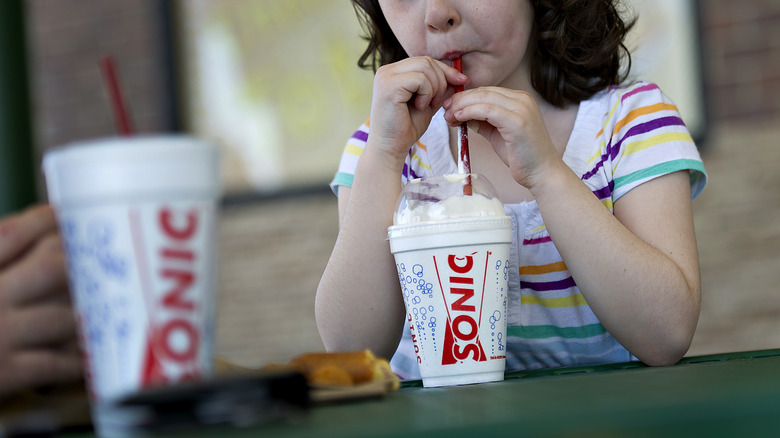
<box><xmin>315</xmin><ymin>149</ymin><xmax>404</xmax><ymax>358</ymax></box>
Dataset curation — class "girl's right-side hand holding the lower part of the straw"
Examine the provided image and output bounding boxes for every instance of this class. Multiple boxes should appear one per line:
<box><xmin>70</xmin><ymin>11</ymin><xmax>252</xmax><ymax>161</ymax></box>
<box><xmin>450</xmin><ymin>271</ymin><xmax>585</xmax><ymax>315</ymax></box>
<box><xmin>443</xmin><ymin>87</ymin><xmax>561</xmax><ymax>190</ymax></box>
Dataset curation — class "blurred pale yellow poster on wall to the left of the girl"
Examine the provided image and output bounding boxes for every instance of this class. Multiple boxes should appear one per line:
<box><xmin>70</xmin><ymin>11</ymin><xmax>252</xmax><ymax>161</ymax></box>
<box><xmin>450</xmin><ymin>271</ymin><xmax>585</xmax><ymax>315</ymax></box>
<box><xmin>178</xmin><ymin>0</ymin><xmax>373</xmax><ymax>193</ymax></box>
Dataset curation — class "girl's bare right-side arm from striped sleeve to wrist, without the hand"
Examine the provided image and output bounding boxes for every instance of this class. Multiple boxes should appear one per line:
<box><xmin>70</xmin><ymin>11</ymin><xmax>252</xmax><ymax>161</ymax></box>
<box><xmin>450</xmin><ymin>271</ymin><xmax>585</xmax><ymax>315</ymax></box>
<box><xmin>532</xmin><ymin>163</ymin><xmax>701</xmax><ymax>365</ymax></box>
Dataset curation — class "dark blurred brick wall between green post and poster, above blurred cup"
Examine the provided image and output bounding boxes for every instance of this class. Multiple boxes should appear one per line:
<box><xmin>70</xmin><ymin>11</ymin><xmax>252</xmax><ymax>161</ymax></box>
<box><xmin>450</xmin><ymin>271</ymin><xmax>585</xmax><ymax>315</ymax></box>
<box><xmin>25</xmin><ymin>0</ymin><xmax>171</xmax><ymax>161</ymax></box>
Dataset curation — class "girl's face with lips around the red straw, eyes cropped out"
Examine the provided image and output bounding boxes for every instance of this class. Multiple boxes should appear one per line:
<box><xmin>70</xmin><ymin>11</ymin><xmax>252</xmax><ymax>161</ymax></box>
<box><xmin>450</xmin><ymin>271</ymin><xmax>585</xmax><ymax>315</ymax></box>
<box><xmin>379</xmin><ymin>0</ymin><xmax>533</xmax><ymax>89</ymax></box>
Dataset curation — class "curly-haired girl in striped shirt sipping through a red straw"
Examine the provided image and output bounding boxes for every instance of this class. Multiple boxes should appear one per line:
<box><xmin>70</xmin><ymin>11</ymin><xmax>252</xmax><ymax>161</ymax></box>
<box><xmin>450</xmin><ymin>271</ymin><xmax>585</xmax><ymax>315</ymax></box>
<box><xmin>316</xmin><ymin>0</ymin><xmax>706</xmax><ymax>378</ymax></box>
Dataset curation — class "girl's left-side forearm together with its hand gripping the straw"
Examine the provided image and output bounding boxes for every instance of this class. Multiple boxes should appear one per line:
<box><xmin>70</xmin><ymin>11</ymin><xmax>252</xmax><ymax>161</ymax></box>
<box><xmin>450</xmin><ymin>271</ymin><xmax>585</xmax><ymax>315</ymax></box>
<box><xmin>315</xmin><ymin>57</ymin><xmax>468</xmax><ymax>358</ymax></box>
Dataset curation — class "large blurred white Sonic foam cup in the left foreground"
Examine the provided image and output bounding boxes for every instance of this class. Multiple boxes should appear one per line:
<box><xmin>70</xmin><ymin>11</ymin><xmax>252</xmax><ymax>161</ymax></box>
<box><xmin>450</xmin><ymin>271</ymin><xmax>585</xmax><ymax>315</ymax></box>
<box><xmin>43</xmin><ymin>135</ymin><xmax>221</xmax><ymax>436</ymax></box>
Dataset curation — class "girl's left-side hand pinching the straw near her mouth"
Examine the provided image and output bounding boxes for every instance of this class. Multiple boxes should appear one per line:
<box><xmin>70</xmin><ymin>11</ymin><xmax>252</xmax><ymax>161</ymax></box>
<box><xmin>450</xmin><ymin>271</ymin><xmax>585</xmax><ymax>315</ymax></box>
<box><xmin>370</xmin><ymin>56</ymin><xmax>468</xmax><ymax>160</ymax></box>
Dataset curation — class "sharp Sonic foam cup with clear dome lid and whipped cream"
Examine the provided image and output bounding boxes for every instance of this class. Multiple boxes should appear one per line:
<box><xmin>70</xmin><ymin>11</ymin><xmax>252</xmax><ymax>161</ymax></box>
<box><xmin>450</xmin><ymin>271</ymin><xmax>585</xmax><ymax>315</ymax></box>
<box><xmin>388</xmin><ymin>174</ymin><xmax>512</xmax><ymax>387</ymax></box>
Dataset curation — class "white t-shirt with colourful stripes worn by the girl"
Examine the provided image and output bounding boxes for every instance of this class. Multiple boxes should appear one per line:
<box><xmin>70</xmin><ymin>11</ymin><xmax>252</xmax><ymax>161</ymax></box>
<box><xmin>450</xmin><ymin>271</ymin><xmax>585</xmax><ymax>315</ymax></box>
<box><xmin>331</xmin><ymin>82</ymin><xmax>707</xmax><ymax>379</ymax></box>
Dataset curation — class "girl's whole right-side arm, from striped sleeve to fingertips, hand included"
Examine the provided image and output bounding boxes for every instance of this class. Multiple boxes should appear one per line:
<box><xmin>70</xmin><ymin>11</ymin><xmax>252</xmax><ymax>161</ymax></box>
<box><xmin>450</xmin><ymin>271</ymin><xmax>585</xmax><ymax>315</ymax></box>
<box><xmin>444</xmin><ymin>87</ymin><xmax>701</xmax><ymax>365</ymax></box>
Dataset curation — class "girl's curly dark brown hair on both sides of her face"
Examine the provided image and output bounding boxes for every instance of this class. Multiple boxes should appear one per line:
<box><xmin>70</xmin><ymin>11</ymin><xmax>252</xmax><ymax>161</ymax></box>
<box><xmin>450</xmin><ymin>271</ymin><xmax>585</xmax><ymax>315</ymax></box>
<box><xmin>352</xmin><ymin>0</ymin><xmax>636</xmax><ymax>107</ymax></box>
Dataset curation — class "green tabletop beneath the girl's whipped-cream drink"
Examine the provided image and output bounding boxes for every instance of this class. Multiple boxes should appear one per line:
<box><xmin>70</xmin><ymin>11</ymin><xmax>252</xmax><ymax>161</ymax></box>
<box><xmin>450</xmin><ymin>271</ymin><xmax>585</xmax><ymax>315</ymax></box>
<box><xmin>238</xmin><ymin>350</ymin><xmax>780</xmax><ymax>437</ymax></box>
